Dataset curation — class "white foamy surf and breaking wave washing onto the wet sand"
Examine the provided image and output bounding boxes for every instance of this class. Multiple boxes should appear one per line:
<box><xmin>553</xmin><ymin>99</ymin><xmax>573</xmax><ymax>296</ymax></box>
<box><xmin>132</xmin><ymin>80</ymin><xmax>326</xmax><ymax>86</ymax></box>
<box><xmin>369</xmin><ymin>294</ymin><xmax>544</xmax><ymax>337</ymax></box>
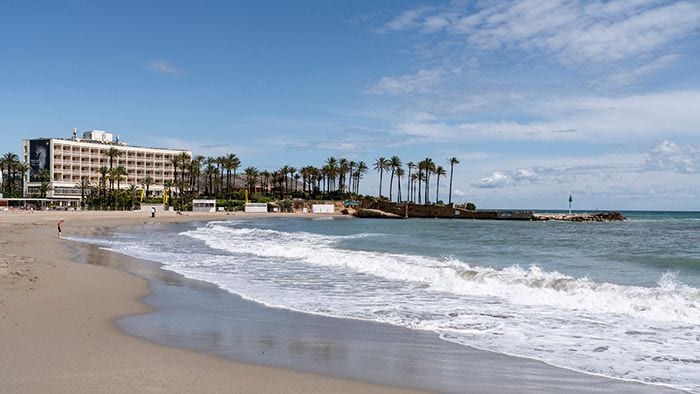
<box><xmin>74</xmin><ymin>222</ymin><xmax>700</xmax><ymax>392</ymax></box>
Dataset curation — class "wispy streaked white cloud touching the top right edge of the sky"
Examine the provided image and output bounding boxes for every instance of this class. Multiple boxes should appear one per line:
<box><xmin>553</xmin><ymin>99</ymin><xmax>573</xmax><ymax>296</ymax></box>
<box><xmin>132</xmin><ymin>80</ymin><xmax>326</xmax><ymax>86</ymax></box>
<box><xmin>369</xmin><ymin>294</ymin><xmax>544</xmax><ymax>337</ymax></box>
<box><xmin>385</xmin><ymin>0</ymin><xmax>700</xmax><ymax>64</ymax></box>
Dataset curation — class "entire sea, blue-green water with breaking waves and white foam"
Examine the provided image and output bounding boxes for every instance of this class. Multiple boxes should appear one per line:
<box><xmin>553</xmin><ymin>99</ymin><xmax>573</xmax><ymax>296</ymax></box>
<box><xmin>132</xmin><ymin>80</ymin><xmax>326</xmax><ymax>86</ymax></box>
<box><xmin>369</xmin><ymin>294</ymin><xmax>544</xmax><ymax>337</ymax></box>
<box><xmin>72</xmin><ymin>212</ymin><xmax>700</xmax><ymax>393</ymax></box>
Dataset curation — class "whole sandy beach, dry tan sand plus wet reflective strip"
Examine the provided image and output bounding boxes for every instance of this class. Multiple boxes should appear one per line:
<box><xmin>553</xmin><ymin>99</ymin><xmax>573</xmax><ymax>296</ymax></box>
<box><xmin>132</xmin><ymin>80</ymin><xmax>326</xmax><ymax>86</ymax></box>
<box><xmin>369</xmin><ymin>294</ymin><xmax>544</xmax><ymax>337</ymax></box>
<box><xmin>0</xmin><ymin>212</ymin><xmax>671</xmax><ymax>393</ymax></box>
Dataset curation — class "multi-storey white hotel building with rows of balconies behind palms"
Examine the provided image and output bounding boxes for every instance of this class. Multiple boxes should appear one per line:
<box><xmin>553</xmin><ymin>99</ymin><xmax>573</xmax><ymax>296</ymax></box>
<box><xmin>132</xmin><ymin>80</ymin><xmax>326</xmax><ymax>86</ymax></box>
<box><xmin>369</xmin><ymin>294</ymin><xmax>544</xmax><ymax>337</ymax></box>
<box><xmin>22</xmin><ymin>130</ymin><xmax>192</xmax><ymax>200</ymax></box>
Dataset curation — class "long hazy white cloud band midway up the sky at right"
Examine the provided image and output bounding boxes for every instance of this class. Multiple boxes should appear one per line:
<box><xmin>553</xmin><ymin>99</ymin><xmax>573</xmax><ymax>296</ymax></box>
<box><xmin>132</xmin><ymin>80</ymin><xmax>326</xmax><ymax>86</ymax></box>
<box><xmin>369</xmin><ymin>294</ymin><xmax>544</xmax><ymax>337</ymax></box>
<box><xmin>396</xmin><ymin>90</ymin><xmax>700</xmax><ymax>143</ymax></box>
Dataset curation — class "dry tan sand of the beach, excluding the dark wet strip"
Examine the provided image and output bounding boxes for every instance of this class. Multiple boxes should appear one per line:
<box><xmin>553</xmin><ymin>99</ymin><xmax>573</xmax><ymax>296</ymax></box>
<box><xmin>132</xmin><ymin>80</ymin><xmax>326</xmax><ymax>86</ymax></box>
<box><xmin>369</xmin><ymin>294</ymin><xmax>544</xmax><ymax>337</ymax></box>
<box><xmin>0</xmin><ymin>212</ymin><xmax>416</xmax><ymax>393</ymax></box>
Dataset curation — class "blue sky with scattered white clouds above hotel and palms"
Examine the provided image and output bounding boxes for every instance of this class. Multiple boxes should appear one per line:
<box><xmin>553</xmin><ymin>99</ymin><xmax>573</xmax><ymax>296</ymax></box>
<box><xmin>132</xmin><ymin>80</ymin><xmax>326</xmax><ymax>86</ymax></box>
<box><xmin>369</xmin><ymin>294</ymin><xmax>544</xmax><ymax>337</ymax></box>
<box><xmin>0</xmin><ymin>0</ymin><xmax>700</xmax><ymax>210</ymax></box>
